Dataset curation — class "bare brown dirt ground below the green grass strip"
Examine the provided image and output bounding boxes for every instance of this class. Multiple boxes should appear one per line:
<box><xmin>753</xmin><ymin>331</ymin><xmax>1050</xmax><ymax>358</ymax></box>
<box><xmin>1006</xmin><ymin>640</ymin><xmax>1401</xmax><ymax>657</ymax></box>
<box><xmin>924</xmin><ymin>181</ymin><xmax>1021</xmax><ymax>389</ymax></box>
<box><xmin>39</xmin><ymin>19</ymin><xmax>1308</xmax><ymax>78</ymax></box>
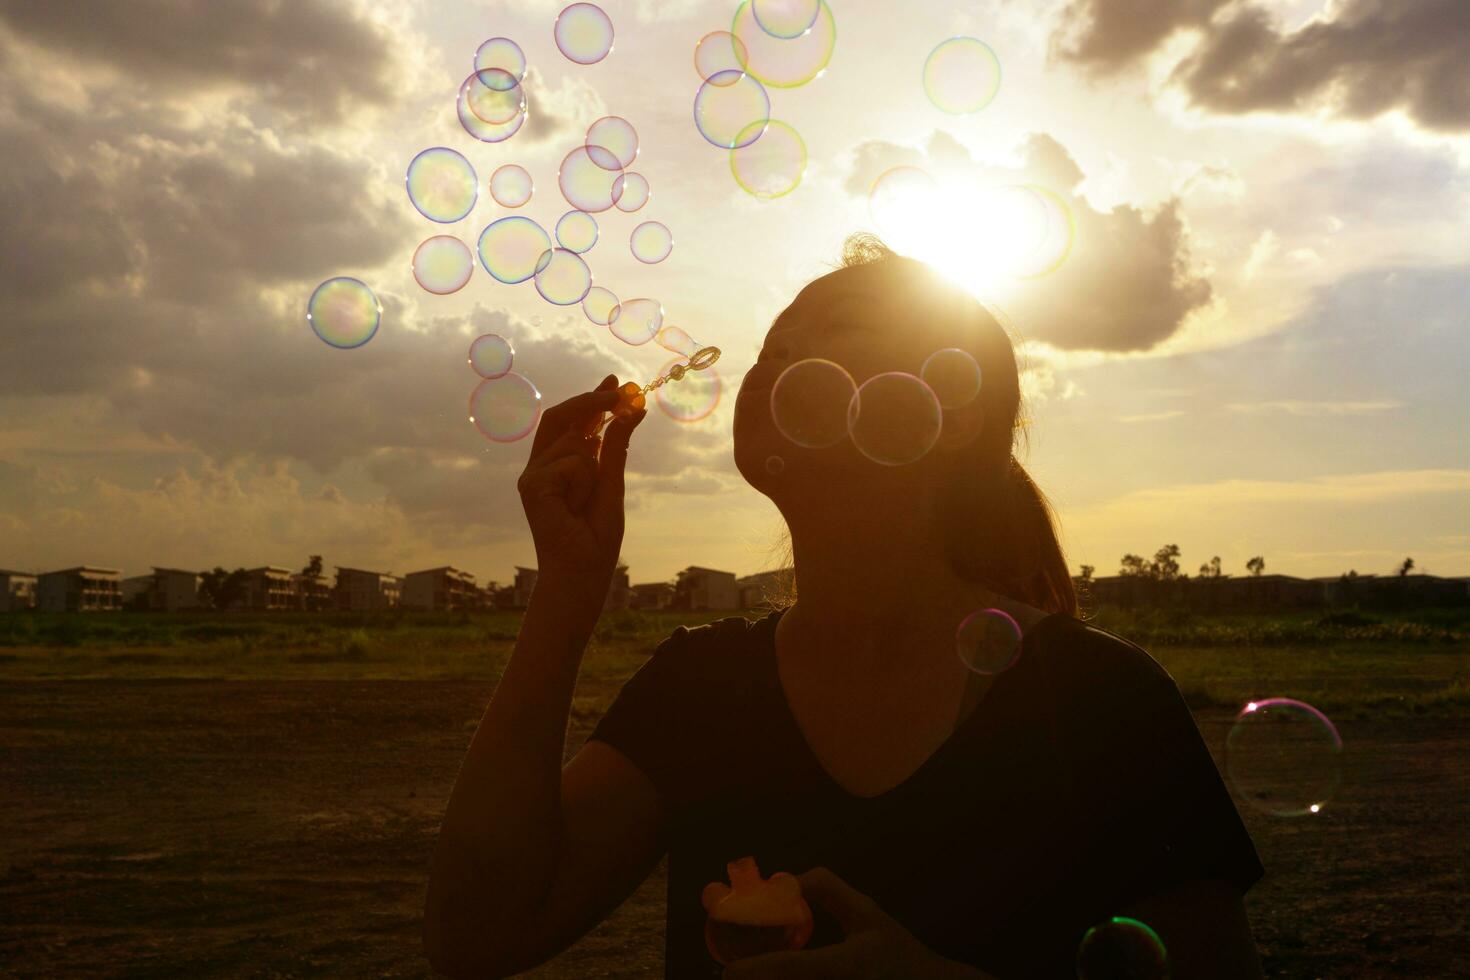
<box><xmin>0</xmin><ymin>680</ymin><xmax>1470</xmax><ymax>980</ymax></box>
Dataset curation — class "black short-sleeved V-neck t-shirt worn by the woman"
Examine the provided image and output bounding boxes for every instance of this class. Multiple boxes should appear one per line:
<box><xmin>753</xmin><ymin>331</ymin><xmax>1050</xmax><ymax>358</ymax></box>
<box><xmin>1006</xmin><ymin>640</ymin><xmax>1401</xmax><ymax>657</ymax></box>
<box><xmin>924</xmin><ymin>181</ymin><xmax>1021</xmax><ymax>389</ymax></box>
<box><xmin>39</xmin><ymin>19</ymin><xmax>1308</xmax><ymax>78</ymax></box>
<box><xmin>589</xmin><ymin>611</ymin><xmax>1263</xmax><ymax>980</ymax></box>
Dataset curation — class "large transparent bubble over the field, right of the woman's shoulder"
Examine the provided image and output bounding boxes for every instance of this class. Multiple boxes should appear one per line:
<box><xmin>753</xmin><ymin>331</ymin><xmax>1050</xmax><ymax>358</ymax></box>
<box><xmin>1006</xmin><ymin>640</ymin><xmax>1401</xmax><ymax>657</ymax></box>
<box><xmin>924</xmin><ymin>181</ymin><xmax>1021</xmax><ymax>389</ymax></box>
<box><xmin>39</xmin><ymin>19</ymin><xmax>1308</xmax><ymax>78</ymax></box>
<box><xmin>1225</xmin><ymin>698</ymin><xmax>1342</xmax><ymax>817</ymax></box>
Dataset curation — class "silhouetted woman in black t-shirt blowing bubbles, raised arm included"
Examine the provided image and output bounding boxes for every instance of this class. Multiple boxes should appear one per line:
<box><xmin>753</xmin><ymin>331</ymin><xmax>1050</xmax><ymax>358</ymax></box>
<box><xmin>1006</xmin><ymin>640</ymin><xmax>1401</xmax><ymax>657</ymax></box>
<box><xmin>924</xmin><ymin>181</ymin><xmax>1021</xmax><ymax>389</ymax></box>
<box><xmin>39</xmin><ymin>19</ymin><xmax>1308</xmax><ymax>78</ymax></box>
<box><xmin>425</xmin><ymin>238</ymin><xmax>1261</xmax><ymax>980</ymax></box>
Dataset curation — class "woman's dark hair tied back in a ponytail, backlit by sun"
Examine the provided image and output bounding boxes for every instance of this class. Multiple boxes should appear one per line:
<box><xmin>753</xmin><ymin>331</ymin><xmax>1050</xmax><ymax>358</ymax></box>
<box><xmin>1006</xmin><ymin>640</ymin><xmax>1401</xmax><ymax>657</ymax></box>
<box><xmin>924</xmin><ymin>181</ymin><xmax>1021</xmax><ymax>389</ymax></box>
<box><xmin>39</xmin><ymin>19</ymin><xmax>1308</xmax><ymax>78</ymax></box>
<box><xmin>766</xmin><ymin>234</ymin><xmax>1078</xmax><ymax>616</ymax></box>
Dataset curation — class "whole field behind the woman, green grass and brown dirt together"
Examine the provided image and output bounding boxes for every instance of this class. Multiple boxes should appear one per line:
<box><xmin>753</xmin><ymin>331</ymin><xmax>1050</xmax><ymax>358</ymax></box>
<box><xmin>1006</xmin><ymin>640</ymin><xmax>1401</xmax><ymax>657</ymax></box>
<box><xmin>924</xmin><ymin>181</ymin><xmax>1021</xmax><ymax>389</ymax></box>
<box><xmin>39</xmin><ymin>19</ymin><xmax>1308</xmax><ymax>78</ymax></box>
<box><xmin>0</xmin><ymin>610</ymin><xmax>1470</xmax><ymax>980</ymax></box>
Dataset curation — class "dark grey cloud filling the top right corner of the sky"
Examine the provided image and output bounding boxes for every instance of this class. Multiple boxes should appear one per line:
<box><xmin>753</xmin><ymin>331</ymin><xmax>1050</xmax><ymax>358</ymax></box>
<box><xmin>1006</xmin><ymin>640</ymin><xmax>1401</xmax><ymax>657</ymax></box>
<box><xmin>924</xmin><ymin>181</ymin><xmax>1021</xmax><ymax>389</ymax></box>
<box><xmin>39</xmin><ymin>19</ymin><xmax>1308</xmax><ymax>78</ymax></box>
<box><xmin>1054</xmin><ymin>0</ymin><xmax>1470</xmax><ymax>132</ymax></box>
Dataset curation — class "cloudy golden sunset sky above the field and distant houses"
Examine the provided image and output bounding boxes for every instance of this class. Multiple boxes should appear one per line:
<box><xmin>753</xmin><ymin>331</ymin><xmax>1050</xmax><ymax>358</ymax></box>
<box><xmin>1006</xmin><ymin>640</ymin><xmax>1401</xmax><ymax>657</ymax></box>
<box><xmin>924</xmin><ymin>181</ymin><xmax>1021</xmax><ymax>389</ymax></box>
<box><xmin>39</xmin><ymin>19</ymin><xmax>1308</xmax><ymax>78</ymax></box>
<box><xmin>0</xmin><ymin>0</ymin><xmax>1470</xmax><ymax>582</ymax></box>
